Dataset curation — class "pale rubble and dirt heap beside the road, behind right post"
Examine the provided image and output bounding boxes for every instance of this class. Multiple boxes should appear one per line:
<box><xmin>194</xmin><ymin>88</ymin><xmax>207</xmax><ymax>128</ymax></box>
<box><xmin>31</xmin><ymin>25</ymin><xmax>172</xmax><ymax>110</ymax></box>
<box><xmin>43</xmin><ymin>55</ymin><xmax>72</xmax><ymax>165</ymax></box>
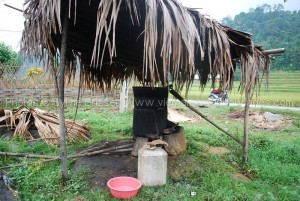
<box><xmin>227</xmin><ymin>110</ymin><xmax>292</xmax><ymax>131</ymax></box>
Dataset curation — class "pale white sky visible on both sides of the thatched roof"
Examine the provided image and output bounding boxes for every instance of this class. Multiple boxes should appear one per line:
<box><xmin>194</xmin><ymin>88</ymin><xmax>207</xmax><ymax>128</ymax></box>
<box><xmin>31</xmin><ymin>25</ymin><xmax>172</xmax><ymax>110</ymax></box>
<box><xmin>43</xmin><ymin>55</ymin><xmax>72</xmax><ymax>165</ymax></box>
<box><xmin>0</xmin><ymin>0</ymin><xmax>300</xmax><ymax>51</ymax></box>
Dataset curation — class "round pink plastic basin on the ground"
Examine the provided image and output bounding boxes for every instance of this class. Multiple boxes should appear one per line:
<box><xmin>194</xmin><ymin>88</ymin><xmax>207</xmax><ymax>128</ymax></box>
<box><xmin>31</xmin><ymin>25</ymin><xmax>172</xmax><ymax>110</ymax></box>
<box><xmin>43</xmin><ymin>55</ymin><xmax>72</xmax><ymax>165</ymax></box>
<box><xmin>107</xmin><ymin>177</ymin><xmax>142</xmax><ymax>199</ymax></box>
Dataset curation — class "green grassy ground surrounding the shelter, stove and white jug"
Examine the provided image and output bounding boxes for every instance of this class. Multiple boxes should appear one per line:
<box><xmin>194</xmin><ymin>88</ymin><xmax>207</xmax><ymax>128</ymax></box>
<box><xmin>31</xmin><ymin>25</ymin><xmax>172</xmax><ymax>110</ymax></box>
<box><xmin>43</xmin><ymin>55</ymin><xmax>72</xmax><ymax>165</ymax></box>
<box><xmin>0</xmin><ymin>103</ymin><xmax>300</xmax><ymax>201</ymax></box>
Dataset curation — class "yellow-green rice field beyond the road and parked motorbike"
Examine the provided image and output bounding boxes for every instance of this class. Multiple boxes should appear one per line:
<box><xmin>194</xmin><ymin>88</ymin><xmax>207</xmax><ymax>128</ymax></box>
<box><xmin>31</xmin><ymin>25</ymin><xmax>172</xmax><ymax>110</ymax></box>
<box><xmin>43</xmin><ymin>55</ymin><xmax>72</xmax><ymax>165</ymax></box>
<box><xmin>183</xmin><ymin>71</ymin><xmax>300</xmax><ymax>107</ymax></box>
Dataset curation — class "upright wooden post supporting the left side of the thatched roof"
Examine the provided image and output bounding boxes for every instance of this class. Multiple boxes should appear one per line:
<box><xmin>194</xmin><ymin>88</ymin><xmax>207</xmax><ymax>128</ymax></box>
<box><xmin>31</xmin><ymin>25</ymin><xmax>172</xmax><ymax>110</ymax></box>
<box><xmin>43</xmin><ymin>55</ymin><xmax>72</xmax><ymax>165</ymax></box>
<box><xmin>58</xmin><ymin>12</ymin><xmax>69</xmax><ymax>186</ymax></box>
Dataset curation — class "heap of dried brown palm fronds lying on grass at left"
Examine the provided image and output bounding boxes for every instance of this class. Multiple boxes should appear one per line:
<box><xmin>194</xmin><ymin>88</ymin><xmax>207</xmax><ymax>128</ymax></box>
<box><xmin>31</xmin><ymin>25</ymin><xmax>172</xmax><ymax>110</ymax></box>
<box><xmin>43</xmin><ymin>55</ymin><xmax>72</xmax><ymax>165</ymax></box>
<box><xmin>0</xmin><ymin>107</ymin><xmax>90</xmax><ymax>145</ymax></box>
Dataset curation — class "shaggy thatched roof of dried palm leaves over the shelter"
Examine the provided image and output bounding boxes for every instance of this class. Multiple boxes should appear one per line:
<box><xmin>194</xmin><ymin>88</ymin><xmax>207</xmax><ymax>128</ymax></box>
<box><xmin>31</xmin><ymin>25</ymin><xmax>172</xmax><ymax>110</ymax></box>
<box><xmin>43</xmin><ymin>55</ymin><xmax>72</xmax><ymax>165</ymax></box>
<box><xmin>21</xmin><ymin>0</ymin><xmax>267</xmax><ymax>91</ymax></box>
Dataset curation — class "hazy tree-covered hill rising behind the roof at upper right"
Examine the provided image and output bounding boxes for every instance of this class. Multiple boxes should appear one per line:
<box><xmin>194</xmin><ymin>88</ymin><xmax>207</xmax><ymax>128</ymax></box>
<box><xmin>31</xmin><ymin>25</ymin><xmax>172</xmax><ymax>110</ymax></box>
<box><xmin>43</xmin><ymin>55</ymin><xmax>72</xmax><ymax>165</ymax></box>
<box><xmin>222</xmin><ymin>4</ymin><xmax>300</xmax><ymax>70</ymax></box>
